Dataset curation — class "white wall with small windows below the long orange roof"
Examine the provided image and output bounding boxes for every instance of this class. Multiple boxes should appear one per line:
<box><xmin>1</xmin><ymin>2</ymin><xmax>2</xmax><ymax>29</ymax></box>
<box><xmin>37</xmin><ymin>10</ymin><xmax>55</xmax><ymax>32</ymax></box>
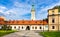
<box><xmin>11</xmin><ymin>25</ymin><xmax>48</xmax><ymax>30</ymax></box>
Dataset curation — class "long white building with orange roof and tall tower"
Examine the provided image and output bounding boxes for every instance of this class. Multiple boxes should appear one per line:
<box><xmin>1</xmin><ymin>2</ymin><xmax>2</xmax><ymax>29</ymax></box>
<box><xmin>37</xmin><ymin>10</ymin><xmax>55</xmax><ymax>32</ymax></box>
<box><xmin>0</xmin><ymin>5</ymin><xmax>48</xmax><ymax>31</ymax></box>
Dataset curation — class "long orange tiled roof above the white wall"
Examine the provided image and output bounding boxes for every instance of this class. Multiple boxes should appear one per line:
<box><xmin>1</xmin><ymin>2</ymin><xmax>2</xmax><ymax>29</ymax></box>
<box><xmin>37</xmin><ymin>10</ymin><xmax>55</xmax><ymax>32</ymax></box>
<box><xmin>0</xmin><ymin>20</ymin><xmax>47</xmax><ymax>25</ymax></box>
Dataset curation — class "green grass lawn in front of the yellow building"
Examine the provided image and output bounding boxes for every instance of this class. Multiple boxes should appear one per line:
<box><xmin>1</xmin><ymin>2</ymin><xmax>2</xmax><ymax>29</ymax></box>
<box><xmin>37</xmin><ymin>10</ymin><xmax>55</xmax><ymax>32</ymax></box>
<box><xmin>39</xmin><ymin>31</ymin><xmax>60</xmax><ymax>37</ymax></box>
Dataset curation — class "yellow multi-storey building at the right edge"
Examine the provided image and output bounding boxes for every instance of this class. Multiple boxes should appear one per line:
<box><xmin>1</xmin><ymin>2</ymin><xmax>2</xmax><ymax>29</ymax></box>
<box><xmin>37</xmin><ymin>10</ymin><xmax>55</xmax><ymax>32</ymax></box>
<box><xmin>48</xmin><ymin>6</ymin><xmax>60</xmax><ymax>31</ymax></box>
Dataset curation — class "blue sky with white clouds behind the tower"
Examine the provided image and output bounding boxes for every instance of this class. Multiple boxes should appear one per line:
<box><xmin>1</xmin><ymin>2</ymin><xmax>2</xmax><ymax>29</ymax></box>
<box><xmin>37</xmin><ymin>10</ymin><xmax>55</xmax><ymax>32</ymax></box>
<box><xmin>0</xmin><ymin>0</ymin><xmax>60</xmax><ymax>20</ymax></box>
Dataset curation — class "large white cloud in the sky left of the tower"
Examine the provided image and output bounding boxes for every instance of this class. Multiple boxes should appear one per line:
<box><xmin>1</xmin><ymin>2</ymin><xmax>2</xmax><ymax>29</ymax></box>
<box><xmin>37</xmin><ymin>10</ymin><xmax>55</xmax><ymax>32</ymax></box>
<box><xmin>1</xmin><ymin>2</ymin><xmax>31</xmax><ymax>19</ymax></box>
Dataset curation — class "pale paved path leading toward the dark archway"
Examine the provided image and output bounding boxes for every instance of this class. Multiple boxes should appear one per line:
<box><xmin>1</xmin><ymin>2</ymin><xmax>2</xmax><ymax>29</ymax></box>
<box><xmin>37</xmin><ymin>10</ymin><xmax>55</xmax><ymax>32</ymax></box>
<box><xmin>3</xmin><ymin>31</ymin><xmax>42</xmax><ymax>37</ymax></box>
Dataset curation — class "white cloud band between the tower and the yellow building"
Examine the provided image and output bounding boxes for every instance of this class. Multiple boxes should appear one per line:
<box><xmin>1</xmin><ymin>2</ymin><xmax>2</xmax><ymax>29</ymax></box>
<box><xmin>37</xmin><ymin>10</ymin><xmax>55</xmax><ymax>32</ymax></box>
<box><xmin>36</xmin><ymin>1</ymin><xmax>60</xmax><ymax>20</ymax></box>
